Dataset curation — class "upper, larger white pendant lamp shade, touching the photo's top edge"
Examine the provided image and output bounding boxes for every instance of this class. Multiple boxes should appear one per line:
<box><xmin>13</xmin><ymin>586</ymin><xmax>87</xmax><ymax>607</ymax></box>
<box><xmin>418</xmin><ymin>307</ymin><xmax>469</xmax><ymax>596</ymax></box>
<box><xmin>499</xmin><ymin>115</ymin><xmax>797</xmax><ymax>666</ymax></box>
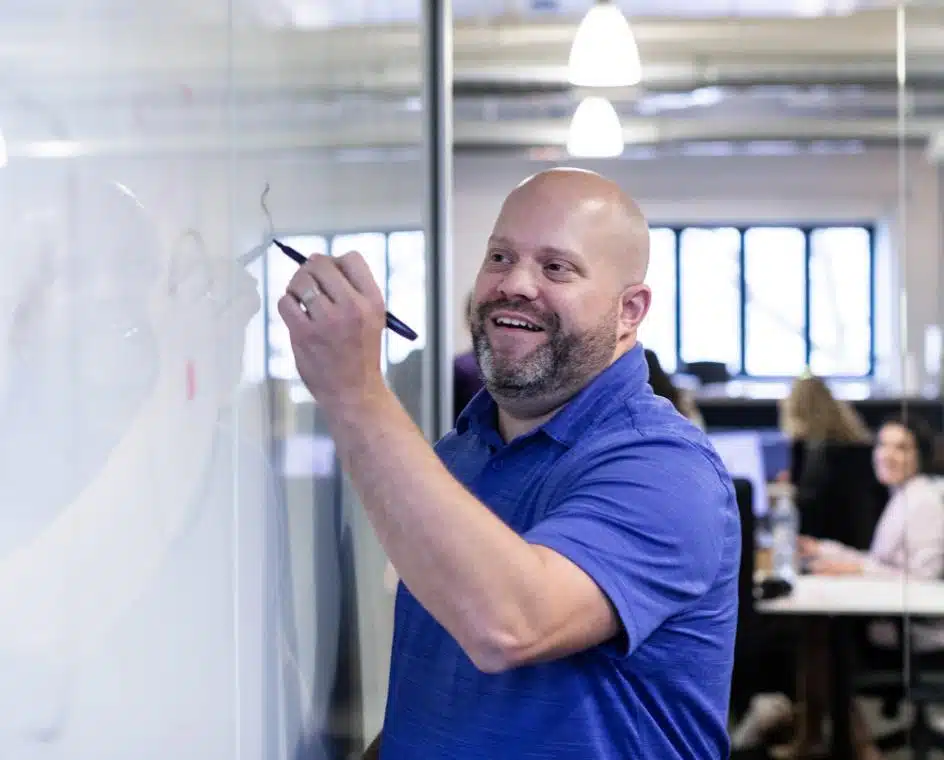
<box><xmin>568</xmin><ymin>0</ymin><xmax>642</xmax><ymax>87</ymax></box>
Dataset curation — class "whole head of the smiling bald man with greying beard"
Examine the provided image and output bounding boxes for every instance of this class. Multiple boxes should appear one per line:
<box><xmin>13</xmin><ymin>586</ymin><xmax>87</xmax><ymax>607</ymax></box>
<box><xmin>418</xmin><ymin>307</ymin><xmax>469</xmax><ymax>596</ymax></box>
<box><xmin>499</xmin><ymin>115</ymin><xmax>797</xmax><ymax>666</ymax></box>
<box><xmin>471</xmin><ymin>169</ymin><xmax>651</xmax><ymax>430</ymax></box>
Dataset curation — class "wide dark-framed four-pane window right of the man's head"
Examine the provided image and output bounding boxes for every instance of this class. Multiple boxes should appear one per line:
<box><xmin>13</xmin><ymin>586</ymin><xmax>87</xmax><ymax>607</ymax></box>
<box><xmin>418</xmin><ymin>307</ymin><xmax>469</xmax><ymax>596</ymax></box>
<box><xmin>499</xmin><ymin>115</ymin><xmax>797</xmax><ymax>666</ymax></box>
<box><xmin>639</xmin><ymin>225</ymin><xmax>874</xmax><ymax>378</ymax></box>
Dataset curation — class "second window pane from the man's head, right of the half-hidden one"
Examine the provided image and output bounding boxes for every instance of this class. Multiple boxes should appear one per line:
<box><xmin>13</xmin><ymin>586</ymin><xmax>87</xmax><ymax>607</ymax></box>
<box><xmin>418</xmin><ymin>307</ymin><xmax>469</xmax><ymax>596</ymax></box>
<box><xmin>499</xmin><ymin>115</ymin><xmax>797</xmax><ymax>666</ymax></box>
<box><xmin>679</xmin><ymin>227</ymin><xmax>741</xmax><ymax>372</ymax></box>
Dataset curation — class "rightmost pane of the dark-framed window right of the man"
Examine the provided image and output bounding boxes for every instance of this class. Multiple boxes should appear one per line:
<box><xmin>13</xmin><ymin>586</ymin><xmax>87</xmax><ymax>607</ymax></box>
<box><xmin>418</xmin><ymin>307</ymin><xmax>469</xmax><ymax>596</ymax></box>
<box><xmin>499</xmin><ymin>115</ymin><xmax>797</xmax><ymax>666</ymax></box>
<box><xmin>810</xmin><ymin>227</ymin><xmax>872</xmax><ymax>375</ymax></box>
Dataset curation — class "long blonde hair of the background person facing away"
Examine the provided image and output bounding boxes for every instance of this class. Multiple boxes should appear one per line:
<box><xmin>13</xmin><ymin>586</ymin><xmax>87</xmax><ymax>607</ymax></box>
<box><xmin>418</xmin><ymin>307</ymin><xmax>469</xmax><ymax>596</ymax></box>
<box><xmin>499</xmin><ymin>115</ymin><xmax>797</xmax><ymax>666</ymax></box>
<box><xmin>780</xmin><ymin>375</ymin><xmax>872</xmax><ymax>443</ymax></box>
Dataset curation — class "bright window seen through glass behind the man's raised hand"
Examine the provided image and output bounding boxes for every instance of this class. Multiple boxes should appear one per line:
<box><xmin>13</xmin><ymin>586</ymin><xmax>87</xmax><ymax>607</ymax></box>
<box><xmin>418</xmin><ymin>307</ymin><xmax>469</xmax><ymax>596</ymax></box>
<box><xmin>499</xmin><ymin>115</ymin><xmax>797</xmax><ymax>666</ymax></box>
<box><xmin>244</xmin><ymin>230</ymin><xmax>427</xmax><ymax>380</ymax></box>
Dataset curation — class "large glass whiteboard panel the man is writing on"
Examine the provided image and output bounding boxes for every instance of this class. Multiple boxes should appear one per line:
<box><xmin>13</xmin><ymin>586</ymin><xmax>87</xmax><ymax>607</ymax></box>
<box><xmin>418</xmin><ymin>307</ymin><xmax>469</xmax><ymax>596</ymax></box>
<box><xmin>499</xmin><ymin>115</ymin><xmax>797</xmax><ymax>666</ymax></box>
<box><xmin>0</xmin><ymin>0</ymin><xmax>433</xmax><ymax>760</ymax></box>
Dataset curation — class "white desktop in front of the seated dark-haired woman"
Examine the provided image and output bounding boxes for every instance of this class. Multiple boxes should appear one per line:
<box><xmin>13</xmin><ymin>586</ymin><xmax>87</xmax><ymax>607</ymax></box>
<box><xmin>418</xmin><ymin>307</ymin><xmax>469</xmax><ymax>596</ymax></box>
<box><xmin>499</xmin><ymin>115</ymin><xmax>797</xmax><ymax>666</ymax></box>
<box><xmin>756</xmin><ymin>575</ymin><xmax>944</xmax><ymax>618</ymax></box>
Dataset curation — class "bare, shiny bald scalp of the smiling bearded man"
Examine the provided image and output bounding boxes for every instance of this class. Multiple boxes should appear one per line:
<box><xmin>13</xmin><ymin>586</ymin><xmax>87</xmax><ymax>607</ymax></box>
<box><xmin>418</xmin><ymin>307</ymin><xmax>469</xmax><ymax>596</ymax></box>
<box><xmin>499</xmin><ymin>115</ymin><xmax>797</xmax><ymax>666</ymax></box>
<box><xmin>499</xmin><ymin>168</ymin><xmax>649</xmax><ymax>287</ymax></box>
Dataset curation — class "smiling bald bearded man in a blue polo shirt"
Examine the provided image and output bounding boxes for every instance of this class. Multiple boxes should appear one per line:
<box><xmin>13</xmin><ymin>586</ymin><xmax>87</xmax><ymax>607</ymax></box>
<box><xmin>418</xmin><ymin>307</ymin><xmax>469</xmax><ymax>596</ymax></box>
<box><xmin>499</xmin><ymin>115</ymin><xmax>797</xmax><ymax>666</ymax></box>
<box><xmin>279</xmin><ymin>169</ymin><xmax>740</xmax><ymax>760</ymax></box>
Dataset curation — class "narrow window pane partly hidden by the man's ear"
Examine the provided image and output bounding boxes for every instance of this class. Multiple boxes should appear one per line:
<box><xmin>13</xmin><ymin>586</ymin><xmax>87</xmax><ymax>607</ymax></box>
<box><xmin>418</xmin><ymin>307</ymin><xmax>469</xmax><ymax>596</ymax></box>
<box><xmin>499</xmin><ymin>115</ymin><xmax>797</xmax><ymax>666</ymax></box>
<box><xmin>639</xmin><ymin>228</ymin><xmax>678</xmax><ymax>373</ymax></box>
